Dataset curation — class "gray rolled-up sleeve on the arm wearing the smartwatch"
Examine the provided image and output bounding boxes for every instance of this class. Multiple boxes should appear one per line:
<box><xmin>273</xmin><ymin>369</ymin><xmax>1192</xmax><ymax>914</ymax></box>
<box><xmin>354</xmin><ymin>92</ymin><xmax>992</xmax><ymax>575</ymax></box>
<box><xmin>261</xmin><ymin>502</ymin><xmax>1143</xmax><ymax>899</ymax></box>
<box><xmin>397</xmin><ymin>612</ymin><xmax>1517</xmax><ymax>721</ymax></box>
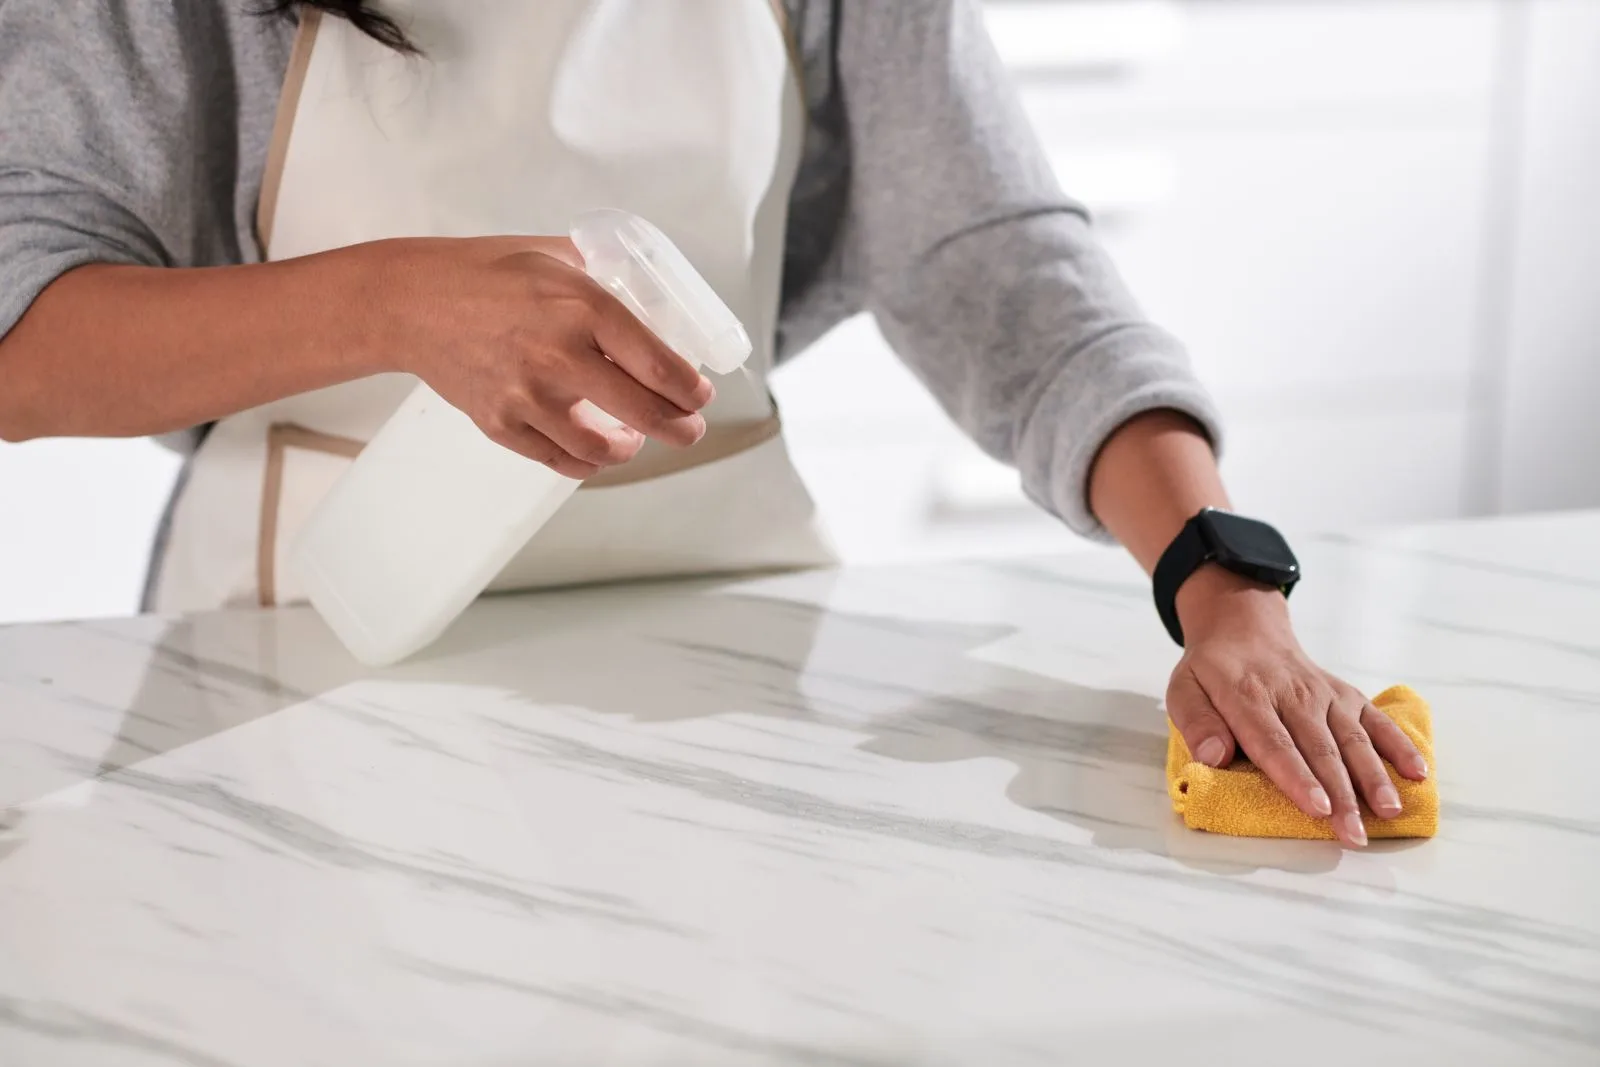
<box><xmin>837</xmin><ymin>0</ymin><xmax>1219</xmax><ymax>539</ymax></box>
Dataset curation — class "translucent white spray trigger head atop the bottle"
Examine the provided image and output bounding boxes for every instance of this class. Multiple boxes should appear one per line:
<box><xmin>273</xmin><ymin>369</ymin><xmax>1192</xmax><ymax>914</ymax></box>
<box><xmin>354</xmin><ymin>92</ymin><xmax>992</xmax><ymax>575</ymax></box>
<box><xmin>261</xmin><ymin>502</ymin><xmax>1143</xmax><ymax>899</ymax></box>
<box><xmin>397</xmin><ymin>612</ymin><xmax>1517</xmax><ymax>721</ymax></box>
<box><xmin>571</xmin><ymin>208</ymin><xmax>750</xmax><ymax>374</ymax></box>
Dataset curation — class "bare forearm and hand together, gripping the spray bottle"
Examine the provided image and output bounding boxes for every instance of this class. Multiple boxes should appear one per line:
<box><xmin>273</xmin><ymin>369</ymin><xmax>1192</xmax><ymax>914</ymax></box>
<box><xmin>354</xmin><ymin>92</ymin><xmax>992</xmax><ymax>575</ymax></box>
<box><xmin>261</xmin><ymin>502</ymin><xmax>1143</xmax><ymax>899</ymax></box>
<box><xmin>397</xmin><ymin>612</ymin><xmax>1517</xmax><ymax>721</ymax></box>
<box><xmin>0</xmin><ymin>237</ymin><xmax>712</xmax><ymax>447</ymax></box>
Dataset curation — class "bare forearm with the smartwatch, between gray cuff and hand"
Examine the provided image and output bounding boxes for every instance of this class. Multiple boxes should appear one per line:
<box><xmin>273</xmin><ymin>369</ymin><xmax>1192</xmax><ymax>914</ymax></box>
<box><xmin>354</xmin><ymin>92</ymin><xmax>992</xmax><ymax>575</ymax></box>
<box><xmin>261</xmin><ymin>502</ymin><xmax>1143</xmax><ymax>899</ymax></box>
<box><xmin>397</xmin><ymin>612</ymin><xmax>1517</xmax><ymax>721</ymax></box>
<box><xmin>1090</xmin><ymin>411</ymin><xmax>1285</xmax><ymax>633</ymax></box>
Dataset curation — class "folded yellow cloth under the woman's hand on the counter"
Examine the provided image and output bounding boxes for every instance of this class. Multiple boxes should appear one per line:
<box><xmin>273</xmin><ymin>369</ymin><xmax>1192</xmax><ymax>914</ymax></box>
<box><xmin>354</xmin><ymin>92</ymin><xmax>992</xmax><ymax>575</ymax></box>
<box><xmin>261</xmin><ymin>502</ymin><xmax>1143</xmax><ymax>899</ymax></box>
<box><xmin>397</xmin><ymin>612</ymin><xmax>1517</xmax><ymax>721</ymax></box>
<box><xmin>1166</xmin><ymin>685</ymin><xmax>1438</xmax><ymax>841</ymax></box>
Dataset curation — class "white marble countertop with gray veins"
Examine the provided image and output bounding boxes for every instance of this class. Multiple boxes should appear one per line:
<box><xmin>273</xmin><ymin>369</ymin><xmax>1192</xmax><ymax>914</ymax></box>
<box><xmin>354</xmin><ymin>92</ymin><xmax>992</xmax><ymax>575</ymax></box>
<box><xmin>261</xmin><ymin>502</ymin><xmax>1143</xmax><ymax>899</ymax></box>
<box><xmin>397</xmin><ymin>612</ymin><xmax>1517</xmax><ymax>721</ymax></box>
<box><xmin>0</xmin><ymin>515</ymin><xmax>1600</xmax><ymax>1067</ymax></box>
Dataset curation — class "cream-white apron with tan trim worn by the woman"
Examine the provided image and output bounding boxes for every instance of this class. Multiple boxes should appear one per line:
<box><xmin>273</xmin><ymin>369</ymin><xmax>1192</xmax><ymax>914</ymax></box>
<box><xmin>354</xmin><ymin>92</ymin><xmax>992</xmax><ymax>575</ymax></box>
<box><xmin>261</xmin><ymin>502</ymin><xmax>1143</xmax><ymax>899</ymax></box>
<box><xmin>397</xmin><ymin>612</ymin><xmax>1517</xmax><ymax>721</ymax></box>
<box><xmin>150</xmin><ymin>0</ymin><xmax>834</xmax><ymax>611</ymax></box>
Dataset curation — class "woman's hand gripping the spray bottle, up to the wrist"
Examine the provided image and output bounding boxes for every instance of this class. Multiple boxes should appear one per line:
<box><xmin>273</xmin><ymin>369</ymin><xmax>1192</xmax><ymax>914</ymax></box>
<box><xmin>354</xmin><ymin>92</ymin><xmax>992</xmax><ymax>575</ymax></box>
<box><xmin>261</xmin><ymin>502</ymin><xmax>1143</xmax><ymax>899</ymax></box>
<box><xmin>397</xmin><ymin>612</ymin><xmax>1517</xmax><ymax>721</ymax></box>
<box><xmin>366</xmin><ymin>237</ymin><xmax>715</xmax><ymax>478</ymax></box>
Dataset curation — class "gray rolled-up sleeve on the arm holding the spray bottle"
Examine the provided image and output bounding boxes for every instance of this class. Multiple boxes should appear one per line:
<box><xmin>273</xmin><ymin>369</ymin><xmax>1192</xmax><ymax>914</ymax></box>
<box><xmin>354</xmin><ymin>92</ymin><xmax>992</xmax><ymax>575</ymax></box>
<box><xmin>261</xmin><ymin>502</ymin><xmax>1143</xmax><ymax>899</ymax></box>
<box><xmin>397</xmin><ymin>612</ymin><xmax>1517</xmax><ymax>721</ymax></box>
<box><xmin>0</xmin><ymin>0</ymin><xmax>268</xmax><ymax>336</ymax></box>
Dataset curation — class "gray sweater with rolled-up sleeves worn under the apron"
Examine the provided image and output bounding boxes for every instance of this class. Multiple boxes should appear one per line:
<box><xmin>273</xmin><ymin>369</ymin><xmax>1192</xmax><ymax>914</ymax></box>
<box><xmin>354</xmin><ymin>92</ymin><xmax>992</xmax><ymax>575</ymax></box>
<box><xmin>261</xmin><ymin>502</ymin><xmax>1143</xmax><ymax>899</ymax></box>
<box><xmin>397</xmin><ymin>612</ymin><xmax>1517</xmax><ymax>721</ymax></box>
<box><xmin>0</xmin><ymin>0</ymin><xmax>1218</xmax><ymax>536</ymax></box>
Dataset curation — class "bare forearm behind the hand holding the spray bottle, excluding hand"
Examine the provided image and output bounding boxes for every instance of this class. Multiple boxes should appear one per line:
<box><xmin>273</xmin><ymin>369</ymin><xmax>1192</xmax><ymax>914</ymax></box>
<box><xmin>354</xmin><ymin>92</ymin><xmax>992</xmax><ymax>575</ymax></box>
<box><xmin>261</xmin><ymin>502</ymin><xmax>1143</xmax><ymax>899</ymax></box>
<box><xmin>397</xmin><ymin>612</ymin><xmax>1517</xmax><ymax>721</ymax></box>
<box><xmin>0</xmin><ymin>250</ymin><xmax>386</xmax><ymax>442</ymax></box>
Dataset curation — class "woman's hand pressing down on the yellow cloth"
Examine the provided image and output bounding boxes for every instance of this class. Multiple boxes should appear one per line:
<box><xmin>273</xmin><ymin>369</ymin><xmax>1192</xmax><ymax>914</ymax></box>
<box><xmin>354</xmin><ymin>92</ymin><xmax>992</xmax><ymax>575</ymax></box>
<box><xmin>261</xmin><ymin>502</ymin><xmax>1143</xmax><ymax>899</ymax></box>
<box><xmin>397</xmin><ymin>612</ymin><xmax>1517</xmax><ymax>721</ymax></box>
<box><xmin>1166</xmin><ymin>565</ymin><xmax>1427</xmax><ymax>848</ymax></box>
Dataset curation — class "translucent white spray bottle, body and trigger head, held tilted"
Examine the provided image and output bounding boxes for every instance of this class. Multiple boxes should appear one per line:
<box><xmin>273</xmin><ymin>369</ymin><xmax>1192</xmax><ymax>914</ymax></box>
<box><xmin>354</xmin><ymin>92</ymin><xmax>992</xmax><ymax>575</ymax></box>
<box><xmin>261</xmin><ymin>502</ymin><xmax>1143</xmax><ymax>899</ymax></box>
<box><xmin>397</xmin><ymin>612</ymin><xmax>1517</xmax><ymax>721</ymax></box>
<box><xmin>291</xmin><ymin>210</ymin><xmax>750</xmax><ymax>665</ymax></box>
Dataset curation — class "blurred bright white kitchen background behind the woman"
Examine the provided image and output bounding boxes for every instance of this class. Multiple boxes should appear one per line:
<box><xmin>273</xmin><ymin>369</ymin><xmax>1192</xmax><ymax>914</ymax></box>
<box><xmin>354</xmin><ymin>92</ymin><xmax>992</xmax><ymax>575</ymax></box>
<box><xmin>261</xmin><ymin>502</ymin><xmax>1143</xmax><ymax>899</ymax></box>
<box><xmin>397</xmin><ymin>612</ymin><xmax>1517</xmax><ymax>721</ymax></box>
<box><xmin>0</xmin><ymin>0</ymin><xmax>1600</xmax><ymax>621</ymax></box>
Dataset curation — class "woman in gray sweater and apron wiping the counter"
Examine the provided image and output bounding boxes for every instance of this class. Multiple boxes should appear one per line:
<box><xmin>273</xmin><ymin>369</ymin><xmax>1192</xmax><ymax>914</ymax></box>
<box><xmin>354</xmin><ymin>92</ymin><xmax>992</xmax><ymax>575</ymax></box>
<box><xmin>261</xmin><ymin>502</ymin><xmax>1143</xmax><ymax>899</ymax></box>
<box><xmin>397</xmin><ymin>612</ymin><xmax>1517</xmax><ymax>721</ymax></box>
<box><xmin>0</xmin><ymin>0</ymin><xmax>1427</xmax><ymax>846</ymax></box>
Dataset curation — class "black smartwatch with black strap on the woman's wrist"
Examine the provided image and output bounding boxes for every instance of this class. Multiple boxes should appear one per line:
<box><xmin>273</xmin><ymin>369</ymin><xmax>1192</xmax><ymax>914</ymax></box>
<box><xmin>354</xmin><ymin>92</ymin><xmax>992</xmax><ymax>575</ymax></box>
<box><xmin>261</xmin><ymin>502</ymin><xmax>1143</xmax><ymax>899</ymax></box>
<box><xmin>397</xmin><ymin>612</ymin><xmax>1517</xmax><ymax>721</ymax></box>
<box><xmin>1152</xmin><ymin>507</ymin><xmax>1301</xmax><ymax>648</ymax></box>
